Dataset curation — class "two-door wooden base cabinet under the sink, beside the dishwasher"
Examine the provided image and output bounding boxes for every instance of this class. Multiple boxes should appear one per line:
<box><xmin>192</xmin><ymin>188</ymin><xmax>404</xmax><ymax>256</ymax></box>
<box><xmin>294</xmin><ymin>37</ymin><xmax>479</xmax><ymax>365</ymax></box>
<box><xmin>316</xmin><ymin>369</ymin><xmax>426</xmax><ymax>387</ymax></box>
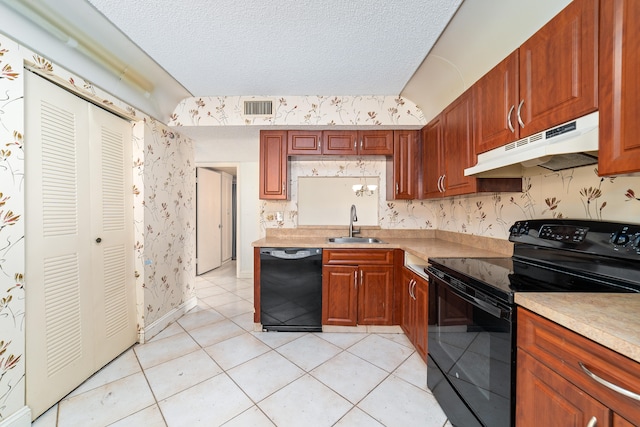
<box><xmin>322</xmin><ymin>249</ymin><xmax>394</xmax><ymax>326</ymax></box>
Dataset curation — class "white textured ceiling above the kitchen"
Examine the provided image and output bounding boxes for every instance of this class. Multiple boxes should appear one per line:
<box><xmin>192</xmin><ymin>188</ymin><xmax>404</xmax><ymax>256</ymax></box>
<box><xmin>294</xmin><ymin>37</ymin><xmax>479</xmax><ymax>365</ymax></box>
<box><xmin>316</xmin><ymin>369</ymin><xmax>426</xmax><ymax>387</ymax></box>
<box><xmin>88</xmin><ymin>0</ymin><xmax>462</xmax><ymax>96</ymax></box>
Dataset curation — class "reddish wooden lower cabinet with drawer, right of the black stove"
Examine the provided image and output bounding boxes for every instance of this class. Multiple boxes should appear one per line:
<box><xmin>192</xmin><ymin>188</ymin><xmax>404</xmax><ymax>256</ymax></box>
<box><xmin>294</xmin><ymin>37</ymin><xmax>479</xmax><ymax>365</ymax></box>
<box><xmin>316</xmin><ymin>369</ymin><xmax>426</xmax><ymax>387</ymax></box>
<box><xmin>516</xmin><ymin>308</ymin><xmax>640</xmax><ymax>427</ymax></box>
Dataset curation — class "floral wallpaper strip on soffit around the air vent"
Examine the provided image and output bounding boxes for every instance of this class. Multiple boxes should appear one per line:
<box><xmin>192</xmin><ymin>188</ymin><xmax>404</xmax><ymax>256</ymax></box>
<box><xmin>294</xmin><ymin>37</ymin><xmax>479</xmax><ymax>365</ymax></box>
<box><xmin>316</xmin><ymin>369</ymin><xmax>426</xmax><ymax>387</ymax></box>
<box><xmin>169</xmin><ymin>96</ymin><xmax>425</xmax><ymax>126</ymax></box>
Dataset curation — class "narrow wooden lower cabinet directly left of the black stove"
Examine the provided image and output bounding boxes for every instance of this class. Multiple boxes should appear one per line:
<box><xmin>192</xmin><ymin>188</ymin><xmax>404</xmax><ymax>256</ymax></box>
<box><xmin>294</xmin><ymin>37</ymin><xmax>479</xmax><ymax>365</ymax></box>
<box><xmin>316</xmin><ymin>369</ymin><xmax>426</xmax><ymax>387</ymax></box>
<box><xmin>400</xmin><ymin>267</ymin><xmax>429</xmax><ymax>362</ymax></box>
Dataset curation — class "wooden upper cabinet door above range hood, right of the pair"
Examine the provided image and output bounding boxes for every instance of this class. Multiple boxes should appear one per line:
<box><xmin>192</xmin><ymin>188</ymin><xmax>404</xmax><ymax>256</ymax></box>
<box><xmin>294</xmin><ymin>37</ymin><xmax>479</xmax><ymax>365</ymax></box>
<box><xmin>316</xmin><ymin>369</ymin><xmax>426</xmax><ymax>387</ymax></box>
<box><xmin>518</xmin><ymin>0</ymin><xmax>600</xmax><ymax>138</ymax></box>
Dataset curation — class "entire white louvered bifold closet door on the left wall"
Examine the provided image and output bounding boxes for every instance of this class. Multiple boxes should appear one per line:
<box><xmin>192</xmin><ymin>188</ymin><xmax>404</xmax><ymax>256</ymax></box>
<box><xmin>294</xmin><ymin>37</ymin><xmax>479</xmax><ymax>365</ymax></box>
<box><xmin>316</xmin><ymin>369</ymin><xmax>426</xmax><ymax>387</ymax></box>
<box><xmin>25</xmin><ymin>72</ymin><xmax>136</xmax><ymax>418</ymax></box>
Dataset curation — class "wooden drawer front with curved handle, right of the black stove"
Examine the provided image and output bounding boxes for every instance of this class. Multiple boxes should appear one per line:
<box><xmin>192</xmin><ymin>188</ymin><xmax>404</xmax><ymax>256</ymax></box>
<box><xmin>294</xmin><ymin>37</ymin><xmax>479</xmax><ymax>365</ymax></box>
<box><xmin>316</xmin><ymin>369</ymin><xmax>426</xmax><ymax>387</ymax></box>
<box><xmin>518</xmin><ymin>308</ymin><xmax>640</xmax><ymax>421</ymax></box>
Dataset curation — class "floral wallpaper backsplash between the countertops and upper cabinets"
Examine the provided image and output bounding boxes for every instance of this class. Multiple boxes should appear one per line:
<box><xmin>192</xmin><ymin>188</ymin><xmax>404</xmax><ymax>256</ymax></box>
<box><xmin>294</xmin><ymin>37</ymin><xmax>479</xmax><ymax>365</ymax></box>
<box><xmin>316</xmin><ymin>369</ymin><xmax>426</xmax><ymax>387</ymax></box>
<box><xmin>260</xmin><ymin>157</ymin><xmax>640</xmax><ymax>239</ymax></box>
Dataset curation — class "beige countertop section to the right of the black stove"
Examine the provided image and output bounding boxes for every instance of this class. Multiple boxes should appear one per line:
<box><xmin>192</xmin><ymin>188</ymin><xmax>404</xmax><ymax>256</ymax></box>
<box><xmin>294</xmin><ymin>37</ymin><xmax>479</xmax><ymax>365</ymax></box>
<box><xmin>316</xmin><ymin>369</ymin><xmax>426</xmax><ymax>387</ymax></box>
<box><xmin>515</xmin><ymin>292</ymin><xmax>640</xmax><ymax>362</ymax></box>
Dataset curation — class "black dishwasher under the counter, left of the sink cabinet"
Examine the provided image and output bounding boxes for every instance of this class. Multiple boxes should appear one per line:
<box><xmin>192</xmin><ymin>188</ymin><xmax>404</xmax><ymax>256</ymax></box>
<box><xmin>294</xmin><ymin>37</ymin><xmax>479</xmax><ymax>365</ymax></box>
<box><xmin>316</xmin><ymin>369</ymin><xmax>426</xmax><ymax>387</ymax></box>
<box><xmin>260</xmin><ymin>248</ymin><xmax>322</xmax><ymax>332</ymax></box>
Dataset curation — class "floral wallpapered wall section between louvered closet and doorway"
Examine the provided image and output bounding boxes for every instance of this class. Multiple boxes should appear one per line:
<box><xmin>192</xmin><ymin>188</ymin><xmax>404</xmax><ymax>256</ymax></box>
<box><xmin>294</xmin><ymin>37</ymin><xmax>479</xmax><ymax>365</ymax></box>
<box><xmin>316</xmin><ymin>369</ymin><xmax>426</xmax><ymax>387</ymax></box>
<box><xmin>137</xmin><ymin>119</ymin><xmax>196</xmax><ymax>325</ymax></box>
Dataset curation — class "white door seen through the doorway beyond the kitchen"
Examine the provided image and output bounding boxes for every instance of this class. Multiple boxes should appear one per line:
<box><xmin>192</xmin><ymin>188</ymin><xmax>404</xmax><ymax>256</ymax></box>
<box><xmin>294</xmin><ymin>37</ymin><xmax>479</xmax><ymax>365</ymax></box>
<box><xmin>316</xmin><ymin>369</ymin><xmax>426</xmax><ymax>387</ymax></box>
<box><xmin>196</xmin><ymin>168</ymin><xmax>222</xmax><ymax>274</ymax></box>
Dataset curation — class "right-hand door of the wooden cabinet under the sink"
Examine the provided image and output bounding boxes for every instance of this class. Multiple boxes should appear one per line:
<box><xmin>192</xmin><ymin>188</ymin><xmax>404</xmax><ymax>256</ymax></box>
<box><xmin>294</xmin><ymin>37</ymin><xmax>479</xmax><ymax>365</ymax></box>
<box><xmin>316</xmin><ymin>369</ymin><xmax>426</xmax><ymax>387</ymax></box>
<box><xmin>358</xmin><ymin>265</ymin><xmax>393</xmax><ymax>325</ymax></box>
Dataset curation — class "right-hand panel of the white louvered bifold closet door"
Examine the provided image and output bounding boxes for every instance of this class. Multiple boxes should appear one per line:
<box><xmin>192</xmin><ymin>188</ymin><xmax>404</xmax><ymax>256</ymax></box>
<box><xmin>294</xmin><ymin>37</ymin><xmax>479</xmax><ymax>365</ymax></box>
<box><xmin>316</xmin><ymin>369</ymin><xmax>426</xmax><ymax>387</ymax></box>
<box><xmin>88</xmin><ymin>104</ymin><xmax>137</xmax><ymax>369</ymax></box>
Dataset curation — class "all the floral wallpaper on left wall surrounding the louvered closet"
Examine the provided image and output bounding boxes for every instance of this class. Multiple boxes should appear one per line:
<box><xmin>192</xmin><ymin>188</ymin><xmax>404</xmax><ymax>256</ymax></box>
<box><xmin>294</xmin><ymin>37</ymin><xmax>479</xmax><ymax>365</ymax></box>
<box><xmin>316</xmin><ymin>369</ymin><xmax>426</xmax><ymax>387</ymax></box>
<box><xmin>0</xmin><ymin>31</ymin><xmax>195</xmax><ymax>422</ymax></box>
